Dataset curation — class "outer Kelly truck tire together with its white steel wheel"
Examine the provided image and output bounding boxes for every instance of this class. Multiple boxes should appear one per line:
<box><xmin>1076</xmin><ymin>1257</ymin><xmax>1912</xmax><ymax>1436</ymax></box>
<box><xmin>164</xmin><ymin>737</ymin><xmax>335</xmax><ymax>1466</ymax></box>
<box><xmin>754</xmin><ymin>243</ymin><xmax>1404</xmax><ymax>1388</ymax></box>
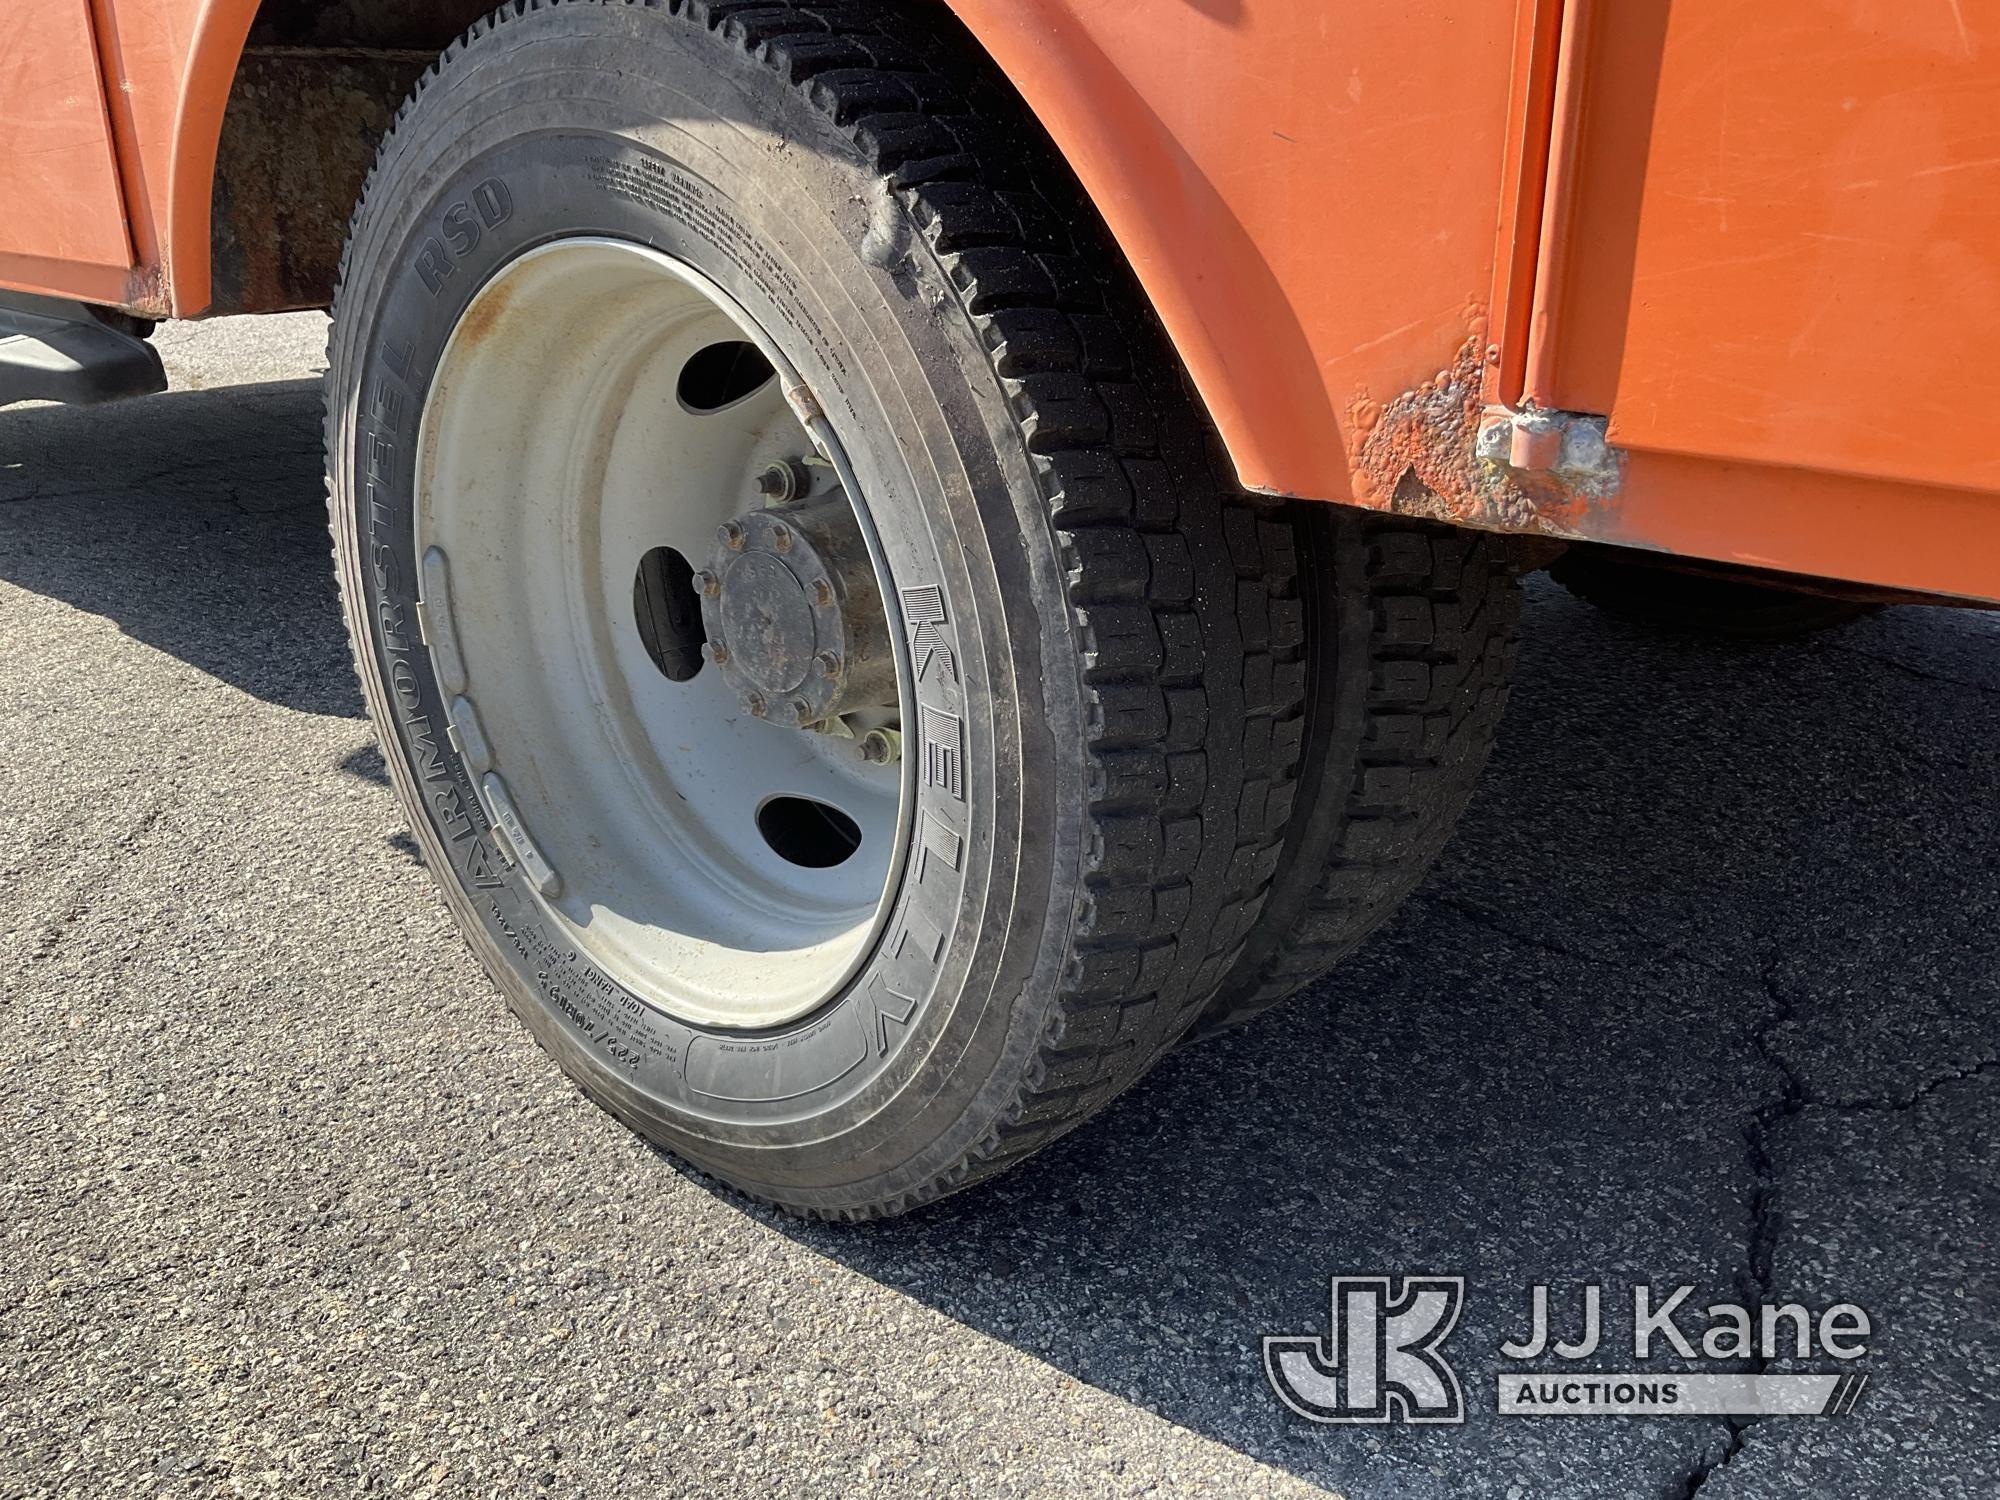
<box><xmin>328</xmin><ymin>0</ymin><xmax>1304</xmax><ymax>1218</ymax></box>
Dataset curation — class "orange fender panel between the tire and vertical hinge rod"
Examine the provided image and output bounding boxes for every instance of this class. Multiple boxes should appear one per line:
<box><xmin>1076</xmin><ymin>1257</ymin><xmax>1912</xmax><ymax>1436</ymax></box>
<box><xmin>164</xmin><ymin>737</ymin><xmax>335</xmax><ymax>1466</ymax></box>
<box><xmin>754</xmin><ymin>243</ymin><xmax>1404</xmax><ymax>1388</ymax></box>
<box><xmin>952</xmin><ymin>0</ymin><xmax>1514</xmax><ymax>498</ymax></box>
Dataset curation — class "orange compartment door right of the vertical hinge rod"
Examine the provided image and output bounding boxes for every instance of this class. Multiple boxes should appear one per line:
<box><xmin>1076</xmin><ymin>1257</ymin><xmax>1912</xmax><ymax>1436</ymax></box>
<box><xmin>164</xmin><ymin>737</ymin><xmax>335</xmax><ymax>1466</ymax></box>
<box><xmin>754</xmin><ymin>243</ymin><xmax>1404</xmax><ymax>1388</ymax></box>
<box><xmin>1532</xmin><ymin>0</ymin><xmax>2000</xmax><ymax>490</ymax></box>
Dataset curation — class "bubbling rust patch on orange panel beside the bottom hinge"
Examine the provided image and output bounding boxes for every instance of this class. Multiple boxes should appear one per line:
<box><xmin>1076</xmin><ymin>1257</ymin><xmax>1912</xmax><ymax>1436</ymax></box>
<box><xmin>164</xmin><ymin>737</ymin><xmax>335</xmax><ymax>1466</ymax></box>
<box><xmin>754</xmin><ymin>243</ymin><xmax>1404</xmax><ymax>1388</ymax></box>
<box><xmin>1348</xmin><ymin>332</ymin><xmax>1602</xmax><ymax>536</ymax></box>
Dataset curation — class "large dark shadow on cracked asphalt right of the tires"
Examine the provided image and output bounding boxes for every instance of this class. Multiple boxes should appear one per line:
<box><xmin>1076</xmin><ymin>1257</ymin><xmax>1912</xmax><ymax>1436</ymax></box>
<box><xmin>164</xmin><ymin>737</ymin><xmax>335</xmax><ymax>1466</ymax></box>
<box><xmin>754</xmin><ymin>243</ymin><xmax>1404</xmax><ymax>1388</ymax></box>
<box><xmin>754</xmin><ymin>580</ymin><xmax>2000</xmax><ymax>1500</ymax></box>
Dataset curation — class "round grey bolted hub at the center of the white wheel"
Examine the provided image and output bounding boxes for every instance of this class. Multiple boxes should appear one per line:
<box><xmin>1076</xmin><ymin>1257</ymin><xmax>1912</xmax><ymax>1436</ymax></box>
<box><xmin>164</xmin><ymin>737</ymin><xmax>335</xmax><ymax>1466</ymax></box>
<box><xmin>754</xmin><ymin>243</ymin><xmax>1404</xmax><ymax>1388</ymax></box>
<box><xmin>694</xmin><ymin>494</ymin><xmax>896</xmax><ymax>728</ymax></box>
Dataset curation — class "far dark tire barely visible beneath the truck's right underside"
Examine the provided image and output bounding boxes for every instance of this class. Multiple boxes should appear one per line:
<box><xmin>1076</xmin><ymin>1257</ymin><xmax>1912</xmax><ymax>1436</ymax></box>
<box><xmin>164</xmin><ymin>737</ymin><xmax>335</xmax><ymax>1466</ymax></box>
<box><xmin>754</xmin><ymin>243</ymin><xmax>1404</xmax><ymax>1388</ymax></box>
<box><xmin>1548</xmin><ymin>546</ymin><xmax>1882</xmax><ymax>640</ymax></box>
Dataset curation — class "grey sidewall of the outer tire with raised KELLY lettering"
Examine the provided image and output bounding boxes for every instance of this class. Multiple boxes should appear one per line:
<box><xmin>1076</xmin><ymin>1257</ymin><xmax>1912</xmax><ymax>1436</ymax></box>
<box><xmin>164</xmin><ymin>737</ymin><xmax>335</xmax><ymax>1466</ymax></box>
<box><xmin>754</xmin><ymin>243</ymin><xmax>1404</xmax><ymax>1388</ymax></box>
<box><xmin>328</xmin><ymin>6</ymin><xmax>1082</xmax><ymax>1208</ymax></box>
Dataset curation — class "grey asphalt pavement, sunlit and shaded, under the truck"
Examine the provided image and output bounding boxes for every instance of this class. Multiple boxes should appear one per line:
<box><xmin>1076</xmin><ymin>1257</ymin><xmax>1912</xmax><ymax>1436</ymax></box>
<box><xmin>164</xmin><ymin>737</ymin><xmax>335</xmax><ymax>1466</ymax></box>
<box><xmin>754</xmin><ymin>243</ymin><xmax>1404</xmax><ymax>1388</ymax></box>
<box><xmin>0</xmin><ymin>316</ymin><xmax>2000</xmax><ymax>1500</ymax></box>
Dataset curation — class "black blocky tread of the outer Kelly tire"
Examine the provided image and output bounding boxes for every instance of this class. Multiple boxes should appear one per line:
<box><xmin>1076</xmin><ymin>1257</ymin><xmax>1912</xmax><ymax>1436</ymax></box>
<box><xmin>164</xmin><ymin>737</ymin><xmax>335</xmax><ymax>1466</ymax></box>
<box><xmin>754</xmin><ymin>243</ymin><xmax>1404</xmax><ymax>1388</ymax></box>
<box><xmin>328</xmin><ymin>0</ymin><xmax>1304</xmax><ymax>1220</ymax></box>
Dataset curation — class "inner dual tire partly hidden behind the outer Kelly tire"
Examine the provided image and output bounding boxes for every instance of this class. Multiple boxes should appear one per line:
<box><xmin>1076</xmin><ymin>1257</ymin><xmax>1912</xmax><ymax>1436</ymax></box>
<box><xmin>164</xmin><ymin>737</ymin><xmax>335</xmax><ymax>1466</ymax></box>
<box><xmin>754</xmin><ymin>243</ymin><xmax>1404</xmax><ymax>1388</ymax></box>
<box><xmin>1188</xmin><ymin>506</ymin><xmax>1520</xmax><ymax>1042</ymax></box>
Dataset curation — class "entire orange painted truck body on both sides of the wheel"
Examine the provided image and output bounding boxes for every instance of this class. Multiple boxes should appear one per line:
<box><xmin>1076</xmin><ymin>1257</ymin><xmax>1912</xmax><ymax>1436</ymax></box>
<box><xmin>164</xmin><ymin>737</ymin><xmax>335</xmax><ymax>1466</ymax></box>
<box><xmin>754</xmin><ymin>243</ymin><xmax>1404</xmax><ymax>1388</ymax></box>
<box><xmin>0</xmin><ymin>0</ymin><xmax>2000</xmax><ymax>600</ymax></box>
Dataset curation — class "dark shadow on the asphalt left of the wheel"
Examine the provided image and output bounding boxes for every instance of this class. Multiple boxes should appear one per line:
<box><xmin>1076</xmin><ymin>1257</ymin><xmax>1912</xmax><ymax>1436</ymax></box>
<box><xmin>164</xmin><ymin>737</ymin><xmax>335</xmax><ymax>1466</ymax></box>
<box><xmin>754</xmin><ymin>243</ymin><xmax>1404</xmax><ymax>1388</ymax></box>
<box><xmin>0</xmin><ymin>380</ymin><xmax>362</xmax><ymax>718</ymax></box>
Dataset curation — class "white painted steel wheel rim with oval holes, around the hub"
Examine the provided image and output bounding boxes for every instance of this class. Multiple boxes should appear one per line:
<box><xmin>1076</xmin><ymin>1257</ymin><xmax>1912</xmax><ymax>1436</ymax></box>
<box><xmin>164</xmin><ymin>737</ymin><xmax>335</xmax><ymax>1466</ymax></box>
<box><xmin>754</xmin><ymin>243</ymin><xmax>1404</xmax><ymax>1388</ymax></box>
<box><xmin>416</xmin><ymin>238</ymin><xmax>914</xmax><ymax>1028</ymax></box>
